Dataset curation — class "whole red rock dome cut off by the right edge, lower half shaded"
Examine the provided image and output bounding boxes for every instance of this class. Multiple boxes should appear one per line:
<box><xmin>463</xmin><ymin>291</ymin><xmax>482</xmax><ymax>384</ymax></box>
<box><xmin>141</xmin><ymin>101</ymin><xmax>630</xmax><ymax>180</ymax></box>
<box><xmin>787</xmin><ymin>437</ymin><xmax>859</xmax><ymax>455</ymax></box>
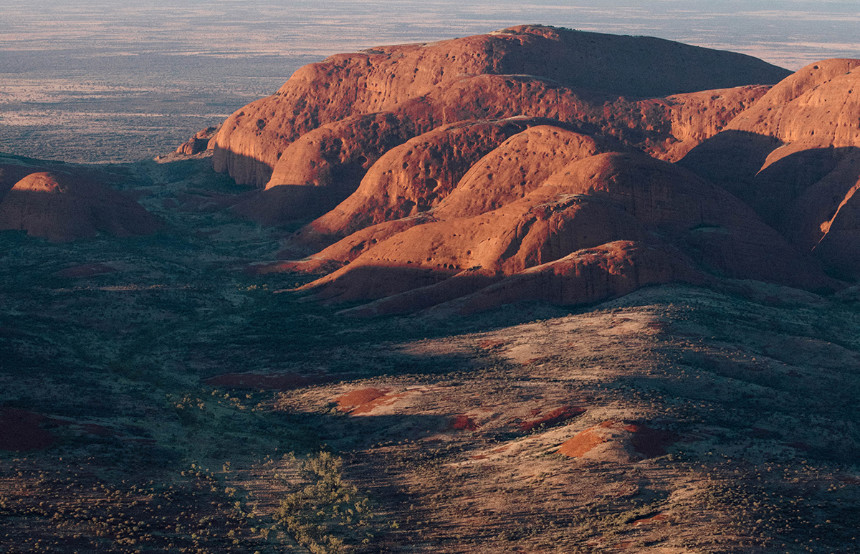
<box><xmin>681</xmin><ymin>59</ymin><xmax>860</xmax><ymax>279</ymax></box>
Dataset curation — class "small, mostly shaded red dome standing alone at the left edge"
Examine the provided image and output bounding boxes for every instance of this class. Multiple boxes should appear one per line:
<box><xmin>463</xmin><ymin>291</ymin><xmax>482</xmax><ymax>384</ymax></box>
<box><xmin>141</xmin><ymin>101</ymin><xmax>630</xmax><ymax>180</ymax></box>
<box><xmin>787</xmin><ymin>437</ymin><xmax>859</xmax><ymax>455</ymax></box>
<box><xmin>0</xmin><ymin>171</ymin><xmax>161</xmax><ymax>242</ymax></box>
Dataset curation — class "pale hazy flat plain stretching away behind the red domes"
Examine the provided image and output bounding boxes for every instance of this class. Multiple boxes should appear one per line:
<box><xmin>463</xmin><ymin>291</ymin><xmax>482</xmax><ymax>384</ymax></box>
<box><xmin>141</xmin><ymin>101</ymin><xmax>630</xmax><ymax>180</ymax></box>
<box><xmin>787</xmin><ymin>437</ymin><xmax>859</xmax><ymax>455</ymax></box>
<box><xmin>0</xmin><ymin>0</ymin><xmax>860</xmax><ymax>161</ymax></box>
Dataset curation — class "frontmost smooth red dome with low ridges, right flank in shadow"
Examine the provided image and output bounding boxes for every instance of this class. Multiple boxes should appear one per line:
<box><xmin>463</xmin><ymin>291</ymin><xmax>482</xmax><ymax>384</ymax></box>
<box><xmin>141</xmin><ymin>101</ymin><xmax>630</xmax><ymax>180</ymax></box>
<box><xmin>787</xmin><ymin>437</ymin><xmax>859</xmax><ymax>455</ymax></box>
<box><xmin>294</xmin><ymin>153</ymin><xmax>825</xmax><ymax>314</ymax></box>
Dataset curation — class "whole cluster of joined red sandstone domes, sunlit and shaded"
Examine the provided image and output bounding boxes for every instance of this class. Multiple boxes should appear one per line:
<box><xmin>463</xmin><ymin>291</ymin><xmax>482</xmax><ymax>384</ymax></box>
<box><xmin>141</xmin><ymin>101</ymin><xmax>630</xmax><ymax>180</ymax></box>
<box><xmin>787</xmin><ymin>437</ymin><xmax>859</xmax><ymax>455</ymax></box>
<box><xmin>205</xmin><ymin>26</ymin><xmax>860</xmax><ymax>315</ymax></box>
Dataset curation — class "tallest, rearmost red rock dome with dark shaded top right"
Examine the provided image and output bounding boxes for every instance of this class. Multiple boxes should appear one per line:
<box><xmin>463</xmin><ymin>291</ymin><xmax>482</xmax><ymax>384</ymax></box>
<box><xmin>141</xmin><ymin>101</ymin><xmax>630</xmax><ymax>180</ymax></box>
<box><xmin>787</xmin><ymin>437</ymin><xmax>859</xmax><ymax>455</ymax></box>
<box><xmin>213</xmin><ymin>26</ymin><xmax>788</xmax><ymax>186</ymax></box>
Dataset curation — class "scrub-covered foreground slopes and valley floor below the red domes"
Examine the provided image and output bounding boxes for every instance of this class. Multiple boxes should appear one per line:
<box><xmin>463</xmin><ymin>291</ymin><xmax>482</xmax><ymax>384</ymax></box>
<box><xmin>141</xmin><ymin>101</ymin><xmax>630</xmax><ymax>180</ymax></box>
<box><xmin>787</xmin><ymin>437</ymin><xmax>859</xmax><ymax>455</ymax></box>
<box><xmin>0</xmin><ymin>150</ymin><xmax>860</xmax><ymax>552</ymax></box>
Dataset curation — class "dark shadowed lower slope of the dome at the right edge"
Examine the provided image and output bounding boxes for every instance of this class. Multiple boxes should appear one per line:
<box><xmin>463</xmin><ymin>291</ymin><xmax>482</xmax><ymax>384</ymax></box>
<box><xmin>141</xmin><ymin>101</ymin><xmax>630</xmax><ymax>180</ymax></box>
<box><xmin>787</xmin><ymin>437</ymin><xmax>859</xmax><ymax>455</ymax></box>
<box><xmin>678</xmin><ymin>131</ymin><xmax>860</xmax><ymax>274</ymax></box>
